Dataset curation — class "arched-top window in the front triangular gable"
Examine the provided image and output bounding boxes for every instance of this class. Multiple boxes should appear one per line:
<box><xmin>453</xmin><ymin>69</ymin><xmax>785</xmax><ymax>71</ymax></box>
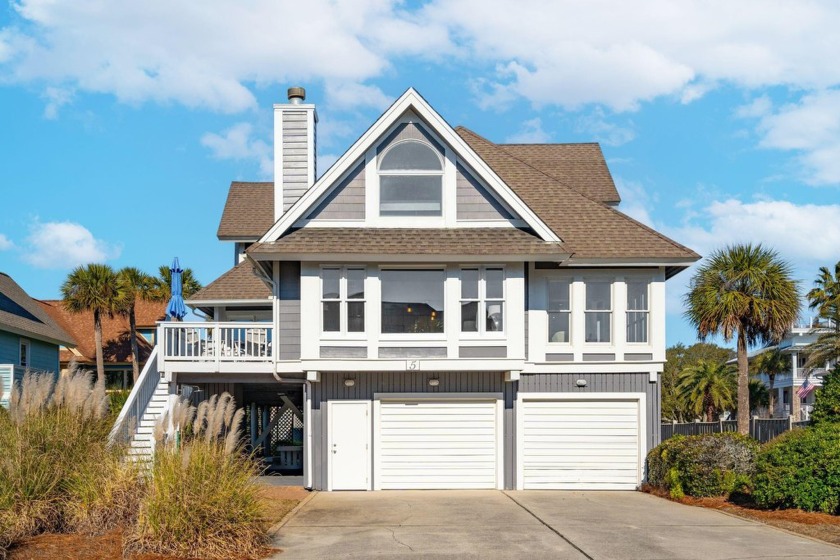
<box><xmin>379</xmin><ymin>140</ymin><xmax>443</xmax><ymax>216</ymax></box>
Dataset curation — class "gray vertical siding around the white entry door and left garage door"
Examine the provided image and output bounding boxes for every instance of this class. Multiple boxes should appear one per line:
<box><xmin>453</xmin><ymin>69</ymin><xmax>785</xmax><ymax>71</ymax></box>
<box><xmin>310</xmin><ymin>372</ymin><xmax>516</xmax><ymax>490</ymax></box>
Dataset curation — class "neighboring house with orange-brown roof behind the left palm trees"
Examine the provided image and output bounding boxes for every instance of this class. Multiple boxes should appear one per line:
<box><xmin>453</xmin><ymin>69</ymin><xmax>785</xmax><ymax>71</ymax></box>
<box><xmin>40</xmin><ymin>300</ymin><xmax>166</xmax><ymax>389</ymax></box>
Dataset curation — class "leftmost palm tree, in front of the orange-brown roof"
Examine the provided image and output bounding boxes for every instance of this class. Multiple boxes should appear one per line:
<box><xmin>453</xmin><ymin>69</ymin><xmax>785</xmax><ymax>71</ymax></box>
<box><xmin>61</xmin><ymin>263</ymin><xmax>121</xmax><ymax>380</ymax></box>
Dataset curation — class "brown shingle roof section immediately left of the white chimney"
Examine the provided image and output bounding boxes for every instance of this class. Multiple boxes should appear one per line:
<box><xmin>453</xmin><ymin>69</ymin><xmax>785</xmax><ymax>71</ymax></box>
<box><xmin>216</xmin><ymin>181</ymin><xmax>274</xmax><ymax>240</ymax></box>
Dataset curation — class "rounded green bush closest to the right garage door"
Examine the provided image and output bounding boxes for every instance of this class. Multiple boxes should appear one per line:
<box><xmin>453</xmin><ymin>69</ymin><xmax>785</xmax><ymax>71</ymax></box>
<box><xmin>647</xmin><ymin>432</ymin><xmax>759</xmax><ymax>499</ymax></box>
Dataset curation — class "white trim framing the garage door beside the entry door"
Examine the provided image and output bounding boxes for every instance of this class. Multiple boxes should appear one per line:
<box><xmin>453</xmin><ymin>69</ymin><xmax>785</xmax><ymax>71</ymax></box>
<box><xmin>373</xmin><ymin>393</ymin><xmax>505</xmax><ymax>490</ymax></box>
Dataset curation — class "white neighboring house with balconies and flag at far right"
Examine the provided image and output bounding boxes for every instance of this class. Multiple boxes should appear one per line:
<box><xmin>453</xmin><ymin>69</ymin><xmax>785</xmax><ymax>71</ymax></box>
<box><xmin>750</xmin><ymin>319</ymin><xmax>832</xmax><ymax>421</ymax></box>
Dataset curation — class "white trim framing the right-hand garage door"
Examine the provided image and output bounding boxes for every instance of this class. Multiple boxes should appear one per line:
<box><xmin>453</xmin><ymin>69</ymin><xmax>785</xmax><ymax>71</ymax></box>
<box><xmin>515</xmin><ymin>392</ymin><xmax>648</xmax><ymax>490</ymax></box>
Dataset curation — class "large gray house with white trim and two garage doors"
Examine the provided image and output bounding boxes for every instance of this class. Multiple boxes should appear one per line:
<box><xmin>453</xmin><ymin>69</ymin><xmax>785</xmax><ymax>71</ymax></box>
<box><xmin>116</xmin><ymin>88</ymin><xmax>699</xmax><ymax>490</ymax></box>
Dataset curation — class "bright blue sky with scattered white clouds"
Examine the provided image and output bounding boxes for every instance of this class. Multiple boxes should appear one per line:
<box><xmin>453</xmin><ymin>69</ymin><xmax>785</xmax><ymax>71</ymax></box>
<box><xmin>0</xmin><ymin>0</ymin><xmax>840</xmax><ymax>345</ymax></box>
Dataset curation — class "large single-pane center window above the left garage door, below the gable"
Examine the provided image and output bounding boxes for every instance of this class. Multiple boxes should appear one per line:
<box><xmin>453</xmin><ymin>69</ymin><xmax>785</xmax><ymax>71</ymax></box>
<box><xmin>381</xmin><ymin>269</ymin><xmax>445</xmax><ymax>334</ymax></box>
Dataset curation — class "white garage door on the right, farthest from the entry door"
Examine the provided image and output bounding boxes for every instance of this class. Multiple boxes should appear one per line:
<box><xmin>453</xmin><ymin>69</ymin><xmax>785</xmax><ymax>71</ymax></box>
<box><xmin>520</xmin><ymin>400</ymin><xmax>642</xmax><ymax>490</ymax></box>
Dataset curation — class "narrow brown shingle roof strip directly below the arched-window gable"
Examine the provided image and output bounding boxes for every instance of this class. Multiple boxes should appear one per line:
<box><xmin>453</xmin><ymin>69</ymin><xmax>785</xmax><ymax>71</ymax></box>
<box><xmin>248</xmin><ymin>227</ymin><xmax>568</xmax><ymax>259</ymax></box>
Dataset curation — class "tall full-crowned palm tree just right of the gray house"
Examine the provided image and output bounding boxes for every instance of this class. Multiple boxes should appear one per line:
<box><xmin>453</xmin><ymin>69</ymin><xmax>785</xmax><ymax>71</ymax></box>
<box><xmin>685</xmin><ymin>244</ymin><xmax>799</xmax><ymax>435</ymax></box>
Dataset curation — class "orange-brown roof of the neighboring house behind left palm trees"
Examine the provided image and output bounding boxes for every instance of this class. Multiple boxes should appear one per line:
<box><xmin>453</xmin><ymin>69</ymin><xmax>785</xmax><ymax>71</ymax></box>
<box><xmin>38</xmin><ymin>300</ymin><xmax>166</xmax><ymax>364</ymax></box>
